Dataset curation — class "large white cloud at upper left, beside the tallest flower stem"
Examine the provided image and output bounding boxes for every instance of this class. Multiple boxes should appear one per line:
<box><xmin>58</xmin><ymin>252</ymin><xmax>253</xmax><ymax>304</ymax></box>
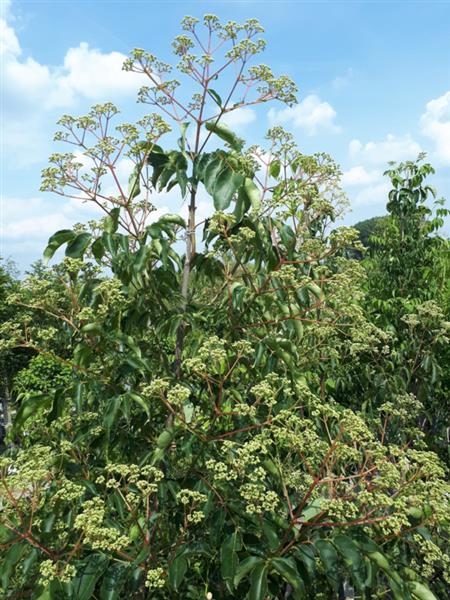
<box><xmin>0</xmin><ymin>5</ymin><xmax>148</xmax><ymax>168</ymax></box>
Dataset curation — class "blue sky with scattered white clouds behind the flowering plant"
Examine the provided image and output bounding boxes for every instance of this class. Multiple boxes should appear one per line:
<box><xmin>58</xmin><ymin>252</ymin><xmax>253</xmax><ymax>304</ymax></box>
<box><xmin>0</xmin><ymin>0</ymin><xmax>450</xmax><ymax>269</ymax></box>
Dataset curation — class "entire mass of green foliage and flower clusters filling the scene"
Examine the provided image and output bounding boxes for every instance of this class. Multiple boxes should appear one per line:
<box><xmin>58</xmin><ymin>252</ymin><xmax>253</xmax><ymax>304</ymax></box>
<box><xmin>0</xmin><ymin>16</ymin><xmax>450</xmax><ymax>600</ymax></box>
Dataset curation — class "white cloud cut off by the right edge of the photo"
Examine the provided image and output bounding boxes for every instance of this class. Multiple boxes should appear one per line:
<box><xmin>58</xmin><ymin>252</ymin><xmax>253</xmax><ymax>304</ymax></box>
<box><xmin>420</xmin><ymin>91</ymin><xmax>450</xmax><ymax>164</ymax></box>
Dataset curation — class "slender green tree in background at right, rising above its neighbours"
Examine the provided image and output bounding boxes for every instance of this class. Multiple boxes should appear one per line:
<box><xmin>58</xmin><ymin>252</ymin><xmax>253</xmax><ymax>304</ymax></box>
<box><xmin>355</xmin><ymin>157</ymin><xmax>450</xmax><ymax>458</ymax></box>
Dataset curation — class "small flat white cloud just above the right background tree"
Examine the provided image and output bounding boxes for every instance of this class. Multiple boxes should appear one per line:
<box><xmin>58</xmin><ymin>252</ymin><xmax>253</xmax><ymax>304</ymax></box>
<box><xmin>349</xmin><ymin>133</ymin><xmax>421</xmax><ymax>165</ymax></box>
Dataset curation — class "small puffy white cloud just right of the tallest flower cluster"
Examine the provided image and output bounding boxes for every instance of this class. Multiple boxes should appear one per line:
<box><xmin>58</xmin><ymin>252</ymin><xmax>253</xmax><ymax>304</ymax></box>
<box><xmin>268</xmin><ymin>94</ymin><xmax>340</xmax><ymax>135</ymax></box>
